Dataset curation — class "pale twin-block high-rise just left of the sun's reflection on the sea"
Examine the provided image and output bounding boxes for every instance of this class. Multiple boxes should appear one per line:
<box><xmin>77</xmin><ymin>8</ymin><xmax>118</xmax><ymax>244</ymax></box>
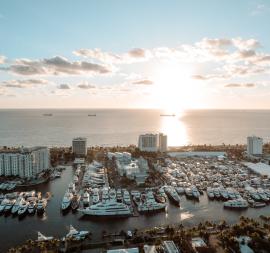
<box><xmin>138</xmin><ymin>133</ymin><xmax>167</xmax><ymax>152</ymax></box>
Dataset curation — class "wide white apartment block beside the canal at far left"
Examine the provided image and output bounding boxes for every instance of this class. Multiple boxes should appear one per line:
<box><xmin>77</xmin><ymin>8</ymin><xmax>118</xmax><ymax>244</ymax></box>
<box><xmin>0</xmin><ymin>147</ymin><xmax>50</xmax><ymax>178</ymax></box>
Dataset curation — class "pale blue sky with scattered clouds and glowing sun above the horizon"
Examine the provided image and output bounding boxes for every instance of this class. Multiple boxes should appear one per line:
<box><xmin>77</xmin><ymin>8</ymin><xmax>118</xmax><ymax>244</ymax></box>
<box><xmin>0</xmin><ymin>0</ymin><xmax>270</xmax><ymax>111</ymax></box>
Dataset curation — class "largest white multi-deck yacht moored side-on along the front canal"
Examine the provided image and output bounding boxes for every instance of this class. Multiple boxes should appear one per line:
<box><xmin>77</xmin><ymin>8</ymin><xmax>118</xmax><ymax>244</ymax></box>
<box><xmin>79</xmin><ymin>200</ymin><xmax>131</xmax><ymax>216</ymax></box>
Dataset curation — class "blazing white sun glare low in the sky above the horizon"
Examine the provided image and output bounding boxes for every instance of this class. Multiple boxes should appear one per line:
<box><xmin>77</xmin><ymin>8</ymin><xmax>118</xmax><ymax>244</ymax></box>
<box><xmin>154</xmin><ymin>62</ymin><xmax>198</xmax><ymax>113</ymax></box>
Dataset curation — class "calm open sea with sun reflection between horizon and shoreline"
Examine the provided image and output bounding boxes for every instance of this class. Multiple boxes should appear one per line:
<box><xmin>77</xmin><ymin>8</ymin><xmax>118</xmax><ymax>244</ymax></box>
<box><xmin>0</xmin><ymin>109</ymin><xmax>270</xmax><ymax>147</ymax></box>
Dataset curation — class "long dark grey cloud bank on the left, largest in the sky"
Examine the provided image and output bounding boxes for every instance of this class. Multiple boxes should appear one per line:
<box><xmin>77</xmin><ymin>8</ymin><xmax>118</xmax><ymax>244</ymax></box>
<box><xmin>2</xmin><ymin>56</ymin><xmax>111</xmax><ymax>76</ymax></box>
